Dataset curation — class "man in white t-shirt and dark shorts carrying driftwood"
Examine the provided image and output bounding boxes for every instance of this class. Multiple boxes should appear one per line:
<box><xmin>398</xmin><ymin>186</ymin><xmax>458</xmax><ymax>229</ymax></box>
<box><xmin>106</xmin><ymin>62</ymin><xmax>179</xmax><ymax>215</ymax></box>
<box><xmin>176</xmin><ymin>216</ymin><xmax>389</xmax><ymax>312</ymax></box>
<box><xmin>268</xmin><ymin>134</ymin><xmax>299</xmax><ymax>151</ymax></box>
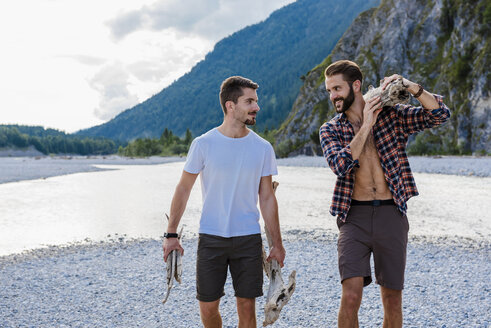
<box><xmin>163</xmin><ymin>76</ymin><xmax>285</xmax><ymax>328</ymax></box>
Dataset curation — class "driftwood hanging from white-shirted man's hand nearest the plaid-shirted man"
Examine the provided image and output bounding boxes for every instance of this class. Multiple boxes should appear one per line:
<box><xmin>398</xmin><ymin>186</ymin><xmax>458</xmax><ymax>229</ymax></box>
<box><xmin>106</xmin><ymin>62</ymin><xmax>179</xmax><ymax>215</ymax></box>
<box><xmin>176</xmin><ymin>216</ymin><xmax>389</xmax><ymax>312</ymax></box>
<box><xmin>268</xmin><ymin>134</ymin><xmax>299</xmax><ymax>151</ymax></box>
<box><xmin>263</xmin><ymin>181</ymin><xmax>296</xmax><ymax>327</ymax></box>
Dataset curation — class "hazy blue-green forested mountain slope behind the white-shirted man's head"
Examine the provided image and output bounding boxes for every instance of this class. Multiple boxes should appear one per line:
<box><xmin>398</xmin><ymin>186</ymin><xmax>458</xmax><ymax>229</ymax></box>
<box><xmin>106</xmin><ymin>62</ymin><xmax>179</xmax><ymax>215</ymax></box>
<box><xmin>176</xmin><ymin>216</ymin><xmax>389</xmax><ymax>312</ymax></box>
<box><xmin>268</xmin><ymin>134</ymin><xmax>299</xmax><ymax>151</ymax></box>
<box><xmin>78</xmin><ymin>0</ymin><xmax>379</xmax><ymax>140</ymax></box>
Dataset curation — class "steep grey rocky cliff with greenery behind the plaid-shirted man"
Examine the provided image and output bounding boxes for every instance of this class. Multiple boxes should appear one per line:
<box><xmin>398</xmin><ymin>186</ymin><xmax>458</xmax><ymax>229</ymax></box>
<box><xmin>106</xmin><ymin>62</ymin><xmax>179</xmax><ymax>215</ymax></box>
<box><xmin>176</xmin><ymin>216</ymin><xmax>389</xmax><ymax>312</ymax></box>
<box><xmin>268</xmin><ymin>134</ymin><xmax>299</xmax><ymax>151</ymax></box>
<box><xmin>275</xmin><ymin>0</ymin><xmax>491</xmax><ymax>156</ymax></box>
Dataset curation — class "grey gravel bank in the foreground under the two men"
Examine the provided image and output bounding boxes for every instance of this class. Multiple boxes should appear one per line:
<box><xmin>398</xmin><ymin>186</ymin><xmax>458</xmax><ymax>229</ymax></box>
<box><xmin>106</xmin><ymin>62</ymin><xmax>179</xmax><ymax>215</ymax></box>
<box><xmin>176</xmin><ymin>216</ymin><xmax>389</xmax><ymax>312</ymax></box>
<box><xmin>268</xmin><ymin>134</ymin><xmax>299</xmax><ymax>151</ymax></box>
<box><xmin>0</xmin><ymin>231</ymin><xmax>491</xmax><ymax>327</ymax></box>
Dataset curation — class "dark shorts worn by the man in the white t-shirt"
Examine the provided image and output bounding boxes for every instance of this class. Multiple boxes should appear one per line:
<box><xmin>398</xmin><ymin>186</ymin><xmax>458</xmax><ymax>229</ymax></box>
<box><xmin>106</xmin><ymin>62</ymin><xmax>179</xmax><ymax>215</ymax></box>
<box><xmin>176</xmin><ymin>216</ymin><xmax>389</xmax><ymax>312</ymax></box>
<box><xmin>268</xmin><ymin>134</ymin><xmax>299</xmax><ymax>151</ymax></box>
<box><xmin>196</xmin><ymin>234</ymin><xmax>263</xmax><ymax>302</ymax></box>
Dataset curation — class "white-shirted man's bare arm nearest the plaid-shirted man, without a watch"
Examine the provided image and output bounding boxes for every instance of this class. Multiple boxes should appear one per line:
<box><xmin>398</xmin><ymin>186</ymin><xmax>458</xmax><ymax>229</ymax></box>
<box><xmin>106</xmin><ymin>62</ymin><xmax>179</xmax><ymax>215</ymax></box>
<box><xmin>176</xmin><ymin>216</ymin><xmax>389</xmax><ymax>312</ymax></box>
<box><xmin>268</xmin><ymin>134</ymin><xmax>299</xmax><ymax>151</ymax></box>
<box><xmin>259</xmin><ymin>176</ymin><xmax>285</xmax><ymax>267</ymax></box>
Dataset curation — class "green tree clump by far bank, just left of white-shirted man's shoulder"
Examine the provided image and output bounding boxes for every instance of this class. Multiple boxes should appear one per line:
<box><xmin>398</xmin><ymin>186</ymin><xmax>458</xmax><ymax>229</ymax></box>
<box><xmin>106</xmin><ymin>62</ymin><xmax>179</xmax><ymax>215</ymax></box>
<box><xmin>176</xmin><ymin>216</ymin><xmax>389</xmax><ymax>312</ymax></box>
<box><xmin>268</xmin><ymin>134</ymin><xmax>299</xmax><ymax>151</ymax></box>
<box><xmin>118</xmin><ymin>128</ymin><xmax>193</xmax><ymax>157</ymax></box>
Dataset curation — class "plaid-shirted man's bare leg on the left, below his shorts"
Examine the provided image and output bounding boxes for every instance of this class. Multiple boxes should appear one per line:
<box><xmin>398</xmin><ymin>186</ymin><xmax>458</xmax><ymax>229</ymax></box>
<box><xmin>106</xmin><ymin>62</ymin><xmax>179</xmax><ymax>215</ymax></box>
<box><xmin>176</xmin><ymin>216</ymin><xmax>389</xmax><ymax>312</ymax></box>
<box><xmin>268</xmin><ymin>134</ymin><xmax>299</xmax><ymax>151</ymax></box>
<box><xmin>338</xmin><ymin>277</ymin><xmax>363</xmax><ymax>328</ymax></box>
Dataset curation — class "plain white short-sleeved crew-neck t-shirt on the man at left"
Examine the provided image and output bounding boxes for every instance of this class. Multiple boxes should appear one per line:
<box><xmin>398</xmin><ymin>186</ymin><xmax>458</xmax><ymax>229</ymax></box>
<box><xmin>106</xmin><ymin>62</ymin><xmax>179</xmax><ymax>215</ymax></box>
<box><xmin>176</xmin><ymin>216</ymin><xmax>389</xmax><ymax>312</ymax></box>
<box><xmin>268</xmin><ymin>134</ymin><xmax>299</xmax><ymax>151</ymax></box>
<box><xmin>184</xmin><ymin>128</ymin><xmax>278</xmax><ymax>237</ymax></box>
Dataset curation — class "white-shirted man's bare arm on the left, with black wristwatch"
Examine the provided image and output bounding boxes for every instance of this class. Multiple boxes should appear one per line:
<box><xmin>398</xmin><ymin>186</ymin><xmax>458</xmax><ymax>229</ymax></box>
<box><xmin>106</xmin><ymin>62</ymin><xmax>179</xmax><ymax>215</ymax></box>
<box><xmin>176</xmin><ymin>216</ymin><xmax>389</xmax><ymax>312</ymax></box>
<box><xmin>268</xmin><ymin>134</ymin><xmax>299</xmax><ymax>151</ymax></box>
<box><xmin>163</xmin><ymin>171</ymin><xmax>198</xmax><ymax>261</ymax></box>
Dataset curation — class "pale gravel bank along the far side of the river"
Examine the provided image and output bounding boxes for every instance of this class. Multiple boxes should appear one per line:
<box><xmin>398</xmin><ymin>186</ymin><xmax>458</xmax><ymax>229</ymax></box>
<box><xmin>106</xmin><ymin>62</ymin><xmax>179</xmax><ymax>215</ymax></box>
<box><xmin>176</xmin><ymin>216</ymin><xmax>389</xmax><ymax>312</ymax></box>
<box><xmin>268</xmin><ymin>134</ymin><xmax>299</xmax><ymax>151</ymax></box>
<box><xmin>0</xmin><ymin>156</ymin><xmax>491</xmax><ymax>184</ymax></box>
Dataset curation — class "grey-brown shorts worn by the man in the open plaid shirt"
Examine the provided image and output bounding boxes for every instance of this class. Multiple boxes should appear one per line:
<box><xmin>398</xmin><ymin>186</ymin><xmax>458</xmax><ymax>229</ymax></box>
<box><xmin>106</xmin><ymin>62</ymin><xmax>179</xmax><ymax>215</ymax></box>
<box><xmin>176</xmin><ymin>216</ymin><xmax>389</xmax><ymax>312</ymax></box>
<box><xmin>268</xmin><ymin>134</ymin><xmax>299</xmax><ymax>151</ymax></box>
<box><xmin>338</xmin><ymin>205</ymin><xmax>409</xmax><ymax>290</ymax></box>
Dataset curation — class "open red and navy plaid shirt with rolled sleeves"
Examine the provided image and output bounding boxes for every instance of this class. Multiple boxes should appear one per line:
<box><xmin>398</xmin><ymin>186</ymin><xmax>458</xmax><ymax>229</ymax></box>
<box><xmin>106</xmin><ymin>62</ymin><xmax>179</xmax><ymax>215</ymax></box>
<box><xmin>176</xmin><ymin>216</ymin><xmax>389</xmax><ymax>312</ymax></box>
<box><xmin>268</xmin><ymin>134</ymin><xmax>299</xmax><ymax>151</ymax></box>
<box><xmin>319</xmin><ymin>95</ymin><xmax>450</xmax><ymax>222</ymax></box>
